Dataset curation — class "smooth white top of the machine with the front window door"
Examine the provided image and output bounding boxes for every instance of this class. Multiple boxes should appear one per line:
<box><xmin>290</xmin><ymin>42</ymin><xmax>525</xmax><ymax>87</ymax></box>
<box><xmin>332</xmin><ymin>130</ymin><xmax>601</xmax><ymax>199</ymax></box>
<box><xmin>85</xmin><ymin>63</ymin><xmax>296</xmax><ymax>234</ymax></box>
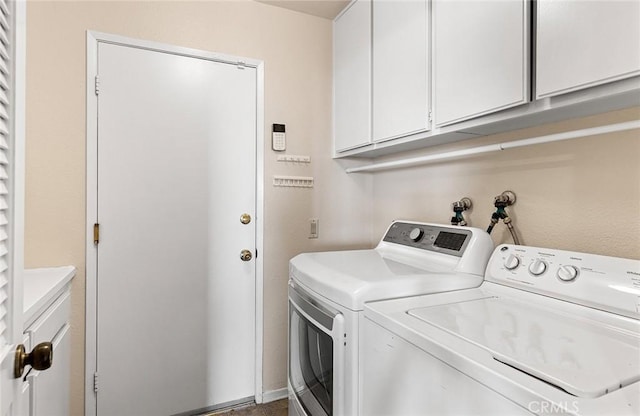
<box><xmin>289</xmin><ymin>249</ymin><xmax>483</xmax><ymax>311</ymax></box>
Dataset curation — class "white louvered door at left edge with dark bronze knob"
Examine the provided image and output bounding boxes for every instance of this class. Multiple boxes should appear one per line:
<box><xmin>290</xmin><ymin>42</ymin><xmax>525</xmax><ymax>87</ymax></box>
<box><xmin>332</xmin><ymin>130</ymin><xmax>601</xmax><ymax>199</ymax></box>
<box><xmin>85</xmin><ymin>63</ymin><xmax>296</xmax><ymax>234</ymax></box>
<box><xmin>0</xmin><ymin>0</ymin><xmax>25</xmax><ymax>416</ymax></box>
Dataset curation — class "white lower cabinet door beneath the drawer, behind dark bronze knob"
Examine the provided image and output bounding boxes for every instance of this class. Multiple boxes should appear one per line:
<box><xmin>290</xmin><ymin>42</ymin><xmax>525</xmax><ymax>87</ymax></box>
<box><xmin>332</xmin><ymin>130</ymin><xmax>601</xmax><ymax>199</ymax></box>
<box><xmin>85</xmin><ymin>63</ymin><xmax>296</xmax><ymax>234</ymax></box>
<box><xmin>29</xmin><ymin>324</ymin><xmax>71</xmax><ymax>416</ymax></box>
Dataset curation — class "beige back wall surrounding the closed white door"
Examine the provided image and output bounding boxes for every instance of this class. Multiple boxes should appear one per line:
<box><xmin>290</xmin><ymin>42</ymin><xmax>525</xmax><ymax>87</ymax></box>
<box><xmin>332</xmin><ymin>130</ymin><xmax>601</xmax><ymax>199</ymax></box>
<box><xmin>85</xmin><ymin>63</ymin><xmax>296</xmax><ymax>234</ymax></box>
<box><xmin>25</xmin><ymin>0</ymin><xmax>373</xmax><ymax>415</ymax></box>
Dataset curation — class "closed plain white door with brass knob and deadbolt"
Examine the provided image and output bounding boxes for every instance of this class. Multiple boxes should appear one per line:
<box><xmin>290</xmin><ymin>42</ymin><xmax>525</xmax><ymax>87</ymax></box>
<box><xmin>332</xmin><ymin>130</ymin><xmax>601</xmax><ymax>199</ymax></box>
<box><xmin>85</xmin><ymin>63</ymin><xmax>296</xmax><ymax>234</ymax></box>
<box><xmin>96</xmin><ymin>42</ymin><xmax>257</xmax><ymax>416</ymax></box>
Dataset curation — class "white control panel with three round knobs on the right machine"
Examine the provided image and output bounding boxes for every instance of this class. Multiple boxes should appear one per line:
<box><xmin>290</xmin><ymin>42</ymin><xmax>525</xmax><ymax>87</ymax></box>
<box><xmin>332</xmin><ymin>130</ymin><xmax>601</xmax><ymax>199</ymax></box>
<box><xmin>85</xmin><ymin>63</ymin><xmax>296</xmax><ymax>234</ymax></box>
<box><xmin>485</xmin><ymin>244</ymin><xmax>640</xmax><ymax>318</ymax></box>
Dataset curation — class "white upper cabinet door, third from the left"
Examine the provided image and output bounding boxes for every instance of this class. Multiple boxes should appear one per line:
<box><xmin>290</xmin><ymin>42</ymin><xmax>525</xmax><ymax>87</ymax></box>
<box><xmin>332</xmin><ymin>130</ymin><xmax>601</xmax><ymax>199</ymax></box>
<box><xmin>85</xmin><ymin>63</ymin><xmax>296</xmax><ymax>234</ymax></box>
<box><xmin>433</xmin><ymin>0</ymin><xmax>530</xmax><ymax>126</ymax></box>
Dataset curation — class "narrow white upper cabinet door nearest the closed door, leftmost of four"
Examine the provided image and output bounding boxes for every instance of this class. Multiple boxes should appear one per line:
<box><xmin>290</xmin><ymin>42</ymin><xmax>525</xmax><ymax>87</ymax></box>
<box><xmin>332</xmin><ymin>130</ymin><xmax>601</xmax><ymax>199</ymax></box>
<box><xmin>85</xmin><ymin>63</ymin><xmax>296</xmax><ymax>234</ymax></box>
<box><xmin>333</xmin><ymin>0</ymin><xmax>371</xmax><ymax>152</ymax></box>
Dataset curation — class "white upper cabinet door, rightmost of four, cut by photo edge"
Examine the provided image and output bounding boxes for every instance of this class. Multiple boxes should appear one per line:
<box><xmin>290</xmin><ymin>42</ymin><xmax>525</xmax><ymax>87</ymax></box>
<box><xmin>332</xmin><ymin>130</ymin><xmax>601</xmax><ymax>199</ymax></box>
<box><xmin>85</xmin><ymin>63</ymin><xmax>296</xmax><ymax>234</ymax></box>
<box><xmin>536</xmin><ymin>0</ymin><xmax>640</xmax><ymax>98</ymax></box>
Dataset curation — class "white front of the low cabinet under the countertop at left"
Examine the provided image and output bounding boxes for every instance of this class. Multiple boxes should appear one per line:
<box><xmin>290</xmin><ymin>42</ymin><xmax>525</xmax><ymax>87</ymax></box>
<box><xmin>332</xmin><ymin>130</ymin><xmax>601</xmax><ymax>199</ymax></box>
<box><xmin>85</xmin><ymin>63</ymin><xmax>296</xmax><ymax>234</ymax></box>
<box><xmin>20</xmin><ymin>289</ymin><xmax>71</xmax><ymax>416</ymax></box>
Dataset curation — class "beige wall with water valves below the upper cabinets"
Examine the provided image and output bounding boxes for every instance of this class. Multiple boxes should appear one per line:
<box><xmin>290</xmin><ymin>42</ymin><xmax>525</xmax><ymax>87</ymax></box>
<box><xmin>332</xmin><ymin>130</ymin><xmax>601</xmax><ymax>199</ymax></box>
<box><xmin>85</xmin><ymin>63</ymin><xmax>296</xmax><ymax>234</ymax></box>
<box><xmin>371</xmin><ymin>108</ymin><xmax>640</xmax><ymax>259</ymax></box>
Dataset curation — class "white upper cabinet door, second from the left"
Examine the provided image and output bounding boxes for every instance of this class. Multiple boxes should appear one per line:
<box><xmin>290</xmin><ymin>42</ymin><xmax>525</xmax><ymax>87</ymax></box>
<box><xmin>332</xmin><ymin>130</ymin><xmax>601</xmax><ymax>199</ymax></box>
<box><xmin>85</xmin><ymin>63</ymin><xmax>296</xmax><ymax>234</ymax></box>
<box><xmin>372</xmin><ymin>0</ymin><xmax>430</xmax><ymax>141</ymax></box>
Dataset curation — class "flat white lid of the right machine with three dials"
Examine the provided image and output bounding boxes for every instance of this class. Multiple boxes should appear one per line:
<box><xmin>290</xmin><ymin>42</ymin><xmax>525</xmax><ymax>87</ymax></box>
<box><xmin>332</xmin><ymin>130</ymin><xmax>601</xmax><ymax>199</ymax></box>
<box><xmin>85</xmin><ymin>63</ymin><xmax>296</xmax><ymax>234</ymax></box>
<box><xmin>408</xmin><ymin>296</ymin><xmax>640</xmax><ymax>398</ymax></box>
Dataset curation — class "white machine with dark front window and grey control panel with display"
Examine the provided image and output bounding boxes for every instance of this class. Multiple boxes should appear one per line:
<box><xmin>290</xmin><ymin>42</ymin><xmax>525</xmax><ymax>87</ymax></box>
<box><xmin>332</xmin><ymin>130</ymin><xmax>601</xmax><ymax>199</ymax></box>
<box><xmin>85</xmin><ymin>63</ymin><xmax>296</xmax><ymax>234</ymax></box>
<box><xmin>288</xmin><ymin>221</ymin><xmax>493</xmax><ymax>416</ymax></box>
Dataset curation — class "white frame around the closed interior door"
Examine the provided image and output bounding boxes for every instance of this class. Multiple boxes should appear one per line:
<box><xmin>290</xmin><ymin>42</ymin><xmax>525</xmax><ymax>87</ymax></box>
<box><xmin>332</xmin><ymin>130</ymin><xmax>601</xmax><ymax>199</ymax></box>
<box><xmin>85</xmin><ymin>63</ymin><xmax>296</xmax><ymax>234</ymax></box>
<box><xmin>84</xmin><ymin>31</ymin><xmax>264</xmax><ymax>416</ymax></box>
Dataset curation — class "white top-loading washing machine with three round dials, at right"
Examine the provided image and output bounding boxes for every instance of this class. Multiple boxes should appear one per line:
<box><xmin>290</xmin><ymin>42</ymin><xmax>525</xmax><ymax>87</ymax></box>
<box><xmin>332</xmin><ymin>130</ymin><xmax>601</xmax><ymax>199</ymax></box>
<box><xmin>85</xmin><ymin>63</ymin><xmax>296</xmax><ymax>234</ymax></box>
<box><xmin>361</xmin><ymin>245</ymin><xmax>640</xmax><ymax>416</ymax></box>
